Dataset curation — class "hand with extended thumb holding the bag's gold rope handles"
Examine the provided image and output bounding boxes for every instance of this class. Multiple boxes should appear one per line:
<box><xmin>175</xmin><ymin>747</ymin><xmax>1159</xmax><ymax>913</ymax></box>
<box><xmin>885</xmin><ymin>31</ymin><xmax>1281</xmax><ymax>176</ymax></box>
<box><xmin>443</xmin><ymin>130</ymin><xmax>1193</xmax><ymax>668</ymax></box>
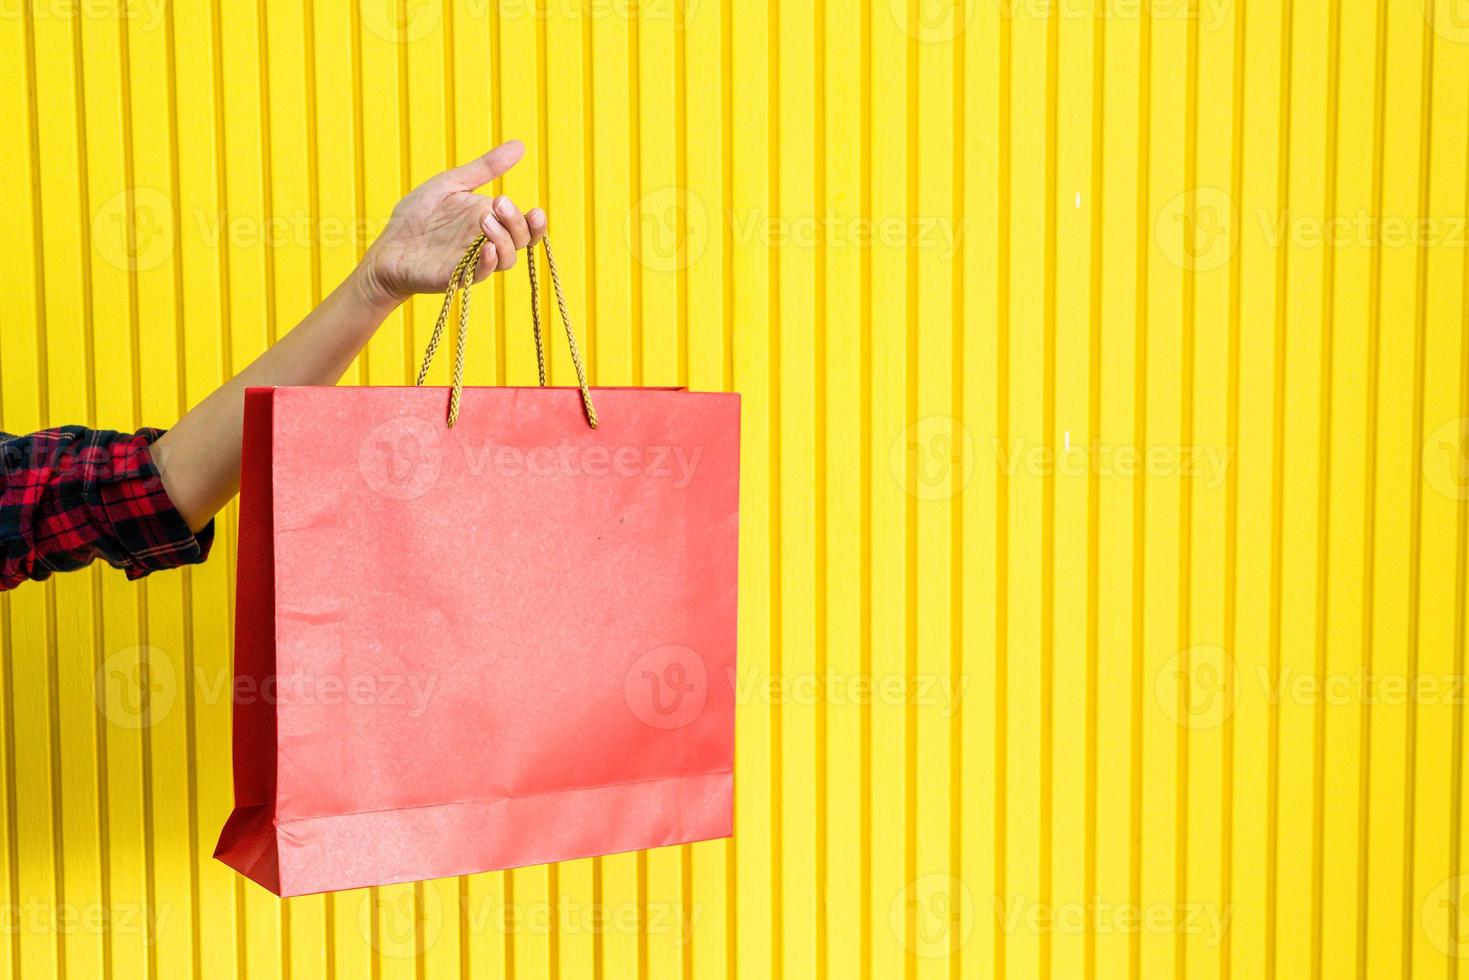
<box><xmin>354</xmin><ymin>140</ymin><xmax>546</xmax><ymax>306</ymax></box>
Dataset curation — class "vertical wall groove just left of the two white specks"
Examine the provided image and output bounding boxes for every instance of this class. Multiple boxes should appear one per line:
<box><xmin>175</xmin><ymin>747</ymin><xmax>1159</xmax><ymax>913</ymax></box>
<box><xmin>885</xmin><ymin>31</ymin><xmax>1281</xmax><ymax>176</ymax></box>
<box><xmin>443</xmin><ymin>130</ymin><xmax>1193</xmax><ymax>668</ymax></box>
<box><xmin>1036</xmin><ymin>3</ymin><xmax>1061</xmax><ymax>980</ymax></box>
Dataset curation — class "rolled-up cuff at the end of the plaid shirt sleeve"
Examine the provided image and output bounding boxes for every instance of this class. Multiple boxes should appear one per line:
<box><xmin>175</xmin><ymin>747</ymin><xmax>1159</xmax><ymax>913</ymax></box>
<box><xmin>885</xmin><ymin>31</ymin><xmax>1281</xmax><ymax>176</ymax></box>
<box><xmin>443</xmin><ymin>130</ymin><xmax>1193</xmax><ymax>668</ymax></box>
<box><xmin>98</xmin><ymin>429</ymin><xmax>214</xmax><ymax>579</ymax></box>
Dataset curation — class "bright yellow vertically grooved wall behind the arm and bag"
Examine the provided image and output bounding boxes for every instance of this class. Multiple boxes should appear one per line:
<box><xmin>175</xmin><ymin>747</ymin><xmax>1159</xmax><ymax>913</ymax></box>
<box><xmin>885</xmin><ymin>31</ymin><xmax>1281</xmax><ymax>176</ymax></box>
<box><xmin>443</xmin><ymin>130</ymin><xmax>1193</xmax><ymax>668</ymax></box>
<box><xmin>0</xmin><ymin>0</ymin><xmax>1469</xmax><ymax>980</ymax></box>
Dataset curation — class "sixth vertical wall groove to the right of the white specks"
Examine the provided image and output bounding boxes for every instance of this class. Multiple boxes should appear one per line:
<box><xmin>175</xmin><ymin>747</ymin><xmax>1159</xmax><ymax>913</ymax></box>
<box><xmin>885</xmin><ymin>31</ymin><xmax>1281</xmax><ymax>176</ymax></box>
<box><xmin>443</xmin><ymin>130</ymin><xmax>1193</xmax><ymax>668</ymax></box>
<box><xmin>1310</xmin><ymin>0</ymin><xmax>1341</xmax><ymax>979</ymax></box>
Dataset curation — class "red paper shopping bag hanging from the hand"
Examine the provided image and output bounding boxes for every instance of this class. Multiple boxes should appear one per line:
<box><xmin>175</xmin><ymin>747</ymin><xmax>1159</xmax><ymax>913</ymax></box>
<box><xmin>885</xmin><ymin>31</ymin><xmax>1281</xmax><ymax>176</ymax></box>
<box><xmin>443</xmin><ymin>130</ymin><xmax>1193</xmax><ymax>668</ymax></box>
<box><xmin>214</xmin><ymin>238</ymin><xmax>739</xmax><ymax>896</ymax></box>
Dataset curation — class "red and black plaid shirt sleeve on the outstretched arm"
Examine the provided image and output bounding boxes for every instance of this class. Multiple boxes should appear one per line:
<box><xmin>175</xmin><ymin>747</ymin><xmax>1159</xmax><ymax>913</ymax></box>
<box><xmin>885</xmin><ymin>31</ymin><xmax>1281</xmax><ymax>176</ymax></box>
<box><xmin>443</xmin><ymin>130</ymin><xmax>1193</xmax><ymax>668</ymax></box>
<box><xmin>0</xmin><ymin>426</ymin><xmax>214</xmax><ymax>591</ymax></box>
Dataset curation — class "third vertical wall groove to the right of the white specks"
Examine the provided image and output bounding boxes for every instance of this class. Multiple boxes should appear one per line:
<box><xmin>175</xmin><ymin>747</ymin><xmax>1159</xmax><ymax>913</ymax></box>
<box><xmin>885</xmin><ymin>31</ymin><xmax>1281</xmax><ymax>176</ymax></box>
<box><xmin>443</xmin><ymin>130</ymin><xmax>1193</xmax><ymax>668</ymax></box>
<box><xmin>1174</xmin><ymin>0</ymin><xmax>1199</xmax><ymax>977</ymax></box>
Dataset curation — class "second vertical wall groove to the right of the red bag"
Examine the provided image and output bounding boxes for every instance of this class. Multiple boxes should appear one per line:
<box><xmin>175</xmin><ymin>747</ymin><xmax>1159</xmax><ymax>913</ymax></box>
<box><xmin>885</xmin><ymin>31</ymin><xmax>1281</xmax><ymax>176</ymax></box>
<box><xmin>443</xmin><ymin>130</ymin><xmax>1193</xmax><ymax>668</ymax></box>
<box><xmin>811</xmin><ymin>0</ymin><xmax>830</xmax><ymax>980</ymax></box>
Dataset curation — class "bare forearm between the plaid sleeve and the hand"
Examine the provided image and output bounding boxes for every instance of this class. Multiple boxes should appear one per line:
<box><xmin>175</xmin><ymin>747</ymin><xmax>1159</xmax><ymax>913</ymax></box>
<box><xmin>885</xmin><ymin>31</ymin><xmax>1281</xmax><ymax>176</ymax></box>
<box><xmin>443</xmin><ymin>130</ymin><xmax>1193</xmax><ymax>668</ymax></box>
<box><xmin>153</xmin><ymin>264</ymin><xmax>397</xmax><ymax>530</ymax></box>
